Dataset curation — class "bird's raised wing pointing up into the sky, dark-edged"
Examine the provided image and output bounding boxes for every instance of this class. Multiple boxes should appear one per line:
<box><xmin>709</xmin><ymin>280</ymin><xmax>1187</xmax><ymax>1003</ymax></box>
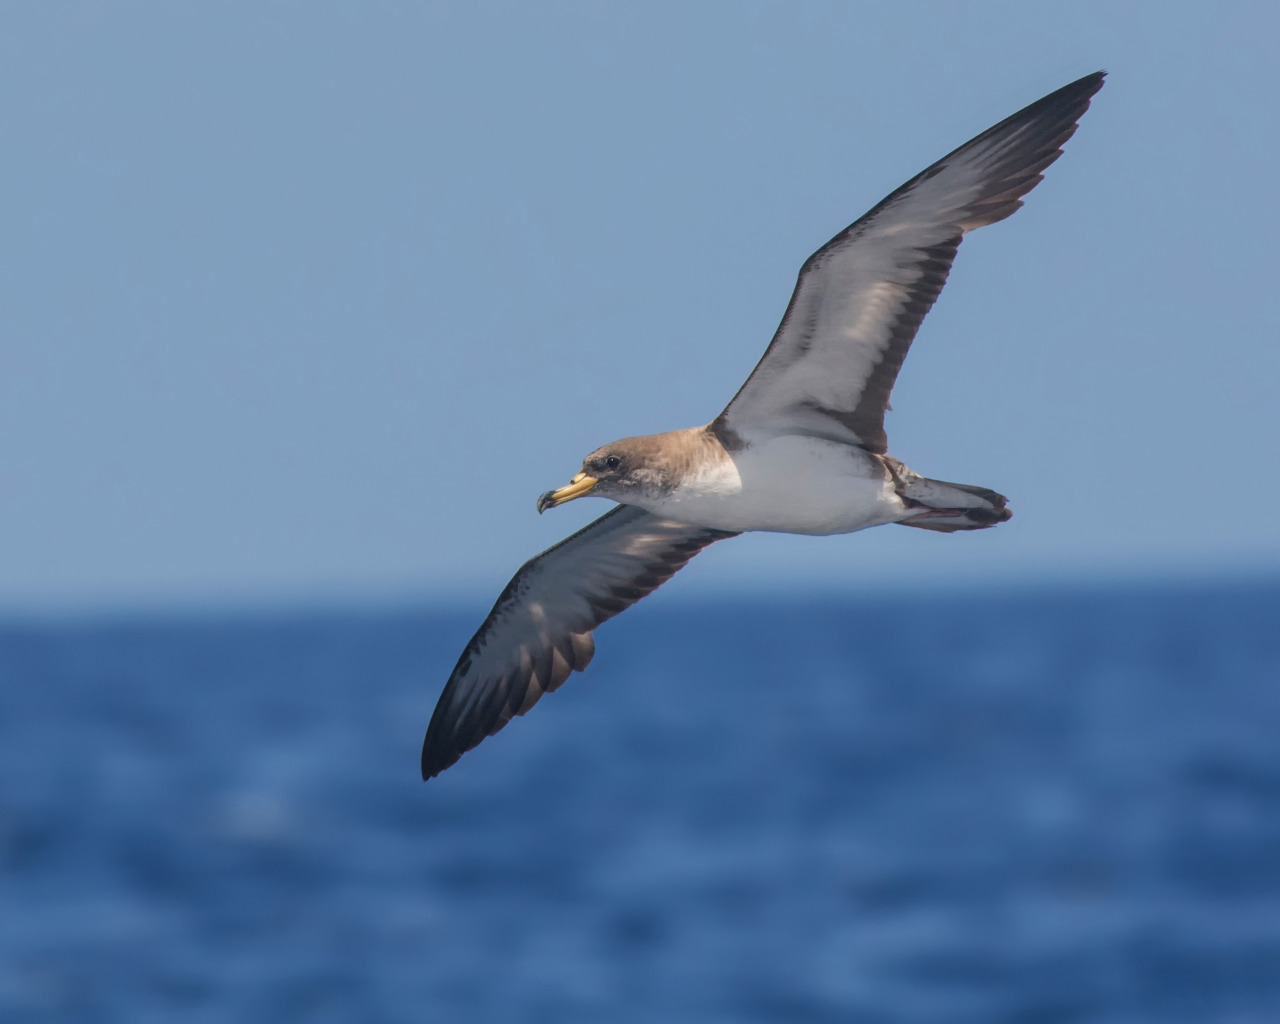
<box><xmin>712</xmin><ymin>72</ymin><xmax>1103</xmax><ymax>453</ymax></box>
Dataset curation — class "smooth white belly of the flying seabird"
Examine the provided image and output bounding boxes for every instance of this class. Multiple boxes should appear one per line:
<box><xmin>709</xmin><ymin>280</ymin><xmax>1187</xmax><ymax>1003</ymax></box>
<box><xmin>649</xmin><ymin>438</ymin><xmax>904</xmax><ymax>535</ymax></box>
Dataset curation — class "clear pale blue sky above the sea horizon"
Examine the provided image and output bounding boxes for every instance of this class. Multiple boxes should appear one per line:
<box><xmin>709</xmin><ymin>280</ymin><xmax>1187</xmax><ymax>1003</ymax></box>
<box><xmin>0</xmin><ymin>3</ymin><xmax>1280</xmax><ymax>609</ymax></box>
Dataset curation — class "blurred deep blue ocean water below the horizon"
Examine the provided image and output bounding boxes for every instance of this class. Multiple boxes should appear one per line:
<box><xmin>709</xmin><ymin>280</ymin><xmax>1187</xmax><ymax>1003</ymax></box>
<box><xmin>0</xmin><ymin>584</ymin><xmax>1280</xmax><ymax>1024</ymax></box>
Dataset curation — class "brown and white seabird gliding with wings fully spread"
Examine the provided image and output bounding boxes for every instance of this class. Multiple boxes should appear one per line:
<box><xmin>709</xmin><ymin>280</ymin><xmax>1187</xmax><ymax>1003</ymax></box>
<box><xmin>422</xmin><ymin>72</ymin><xmax>1103</xmax><ymax>778</ymax></box>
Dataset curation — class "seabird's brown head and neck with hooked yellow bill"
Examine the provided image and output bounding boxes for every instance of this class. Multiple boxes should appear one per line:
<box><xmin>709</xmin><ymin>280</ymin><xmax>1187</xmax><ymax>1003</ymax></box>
<box><xmin>538</xmin><ymin>428</ymin><xmax>705</xmax><ymax>512</ymax></box>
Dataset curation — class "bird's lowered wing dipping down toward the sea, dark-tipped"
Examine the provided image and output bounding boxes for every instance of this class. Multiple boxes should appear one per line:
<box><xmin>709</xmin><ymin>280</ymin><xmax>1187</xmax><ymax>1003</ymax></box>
<box><xmin>422</xmin><ymin>506</ymin><xmax>735</xmax><ymax>778</ymax></box>
